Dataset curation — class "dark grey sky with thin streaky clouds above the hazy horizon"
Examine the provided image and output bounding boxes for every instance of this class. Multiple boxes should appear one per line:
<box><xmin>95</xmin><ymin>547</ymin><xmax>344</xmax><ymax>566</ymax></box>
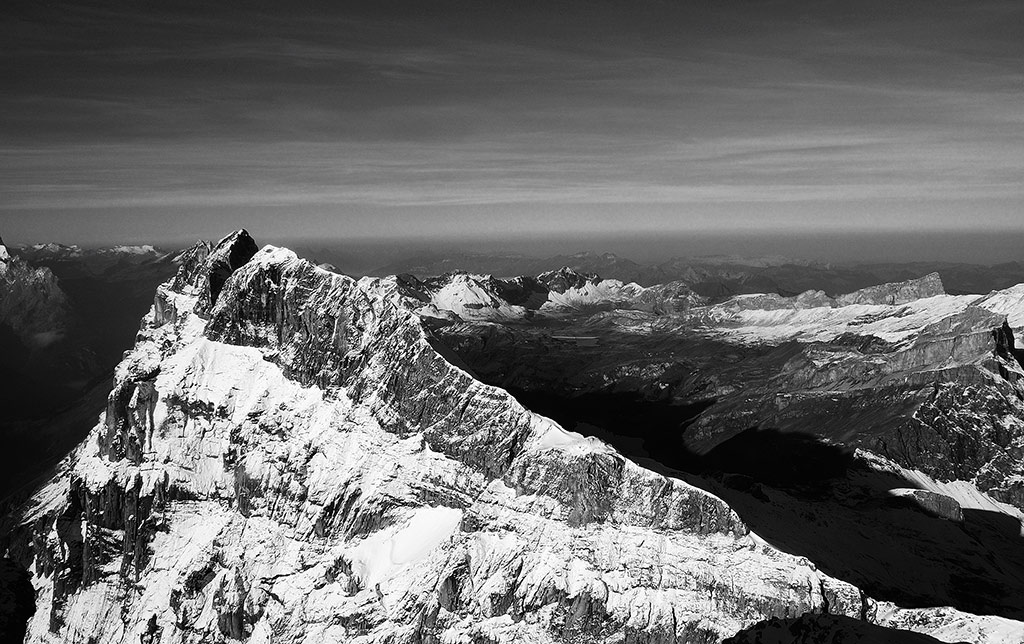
<box><xmin>0</xmin><ymin>0</ymin><xmax>1024</xmax><ymax>251</ymax></box>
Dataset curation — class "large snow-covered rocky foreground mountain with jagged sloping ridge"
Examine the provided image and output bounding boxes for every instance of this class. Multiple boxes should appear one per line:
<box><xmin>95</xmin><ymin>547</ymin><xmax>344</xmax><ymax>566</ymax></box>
<box><xmin>4</xmin><ymin>231</ymin><xmax>1019</xmax><ymax>642</ymax></box>
